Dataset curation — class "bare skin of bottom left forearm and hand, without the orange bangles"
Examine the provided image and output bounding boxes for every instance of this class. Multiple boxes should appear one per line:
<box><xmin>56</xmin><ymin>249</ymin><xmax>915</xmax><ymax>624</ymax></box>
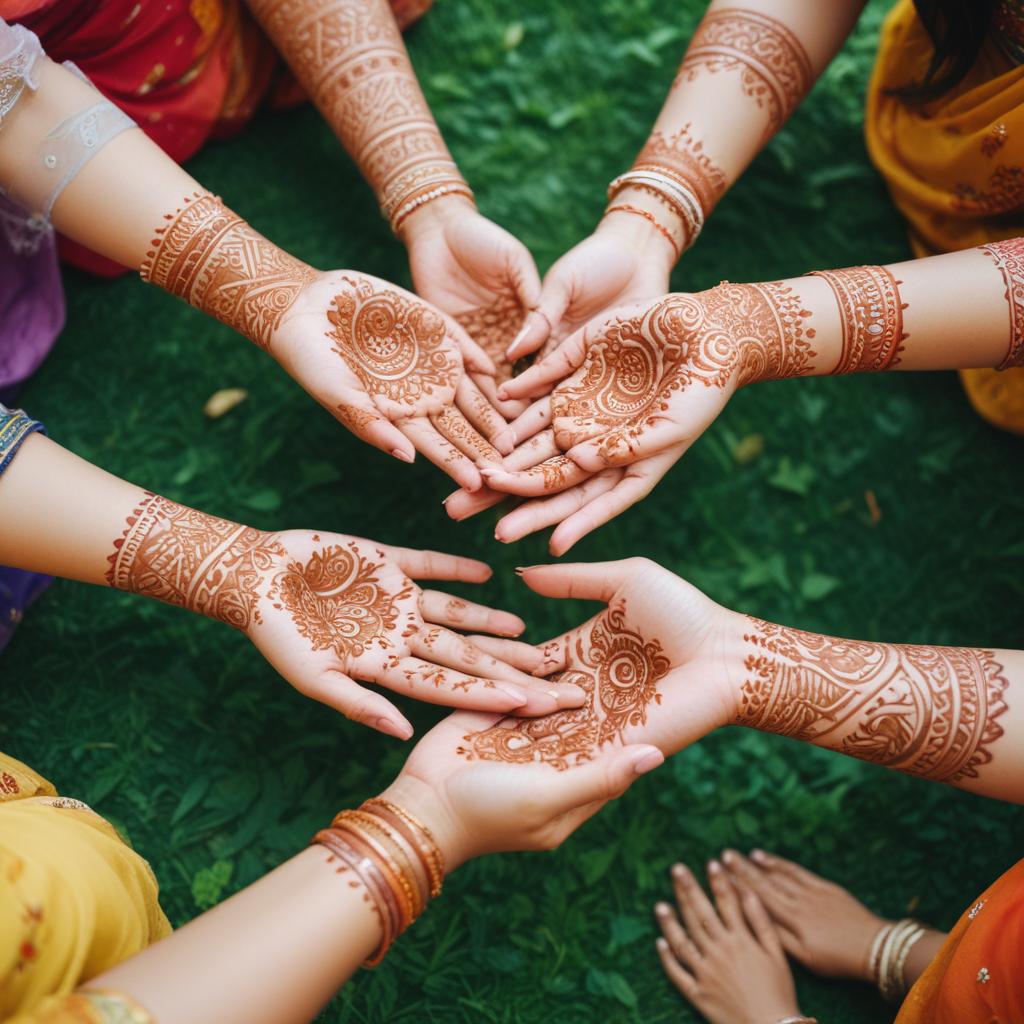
<box><xmin>77</xmin><ymin>712</ymin><xmax>663</xmax><ymax>1024</ymax></box>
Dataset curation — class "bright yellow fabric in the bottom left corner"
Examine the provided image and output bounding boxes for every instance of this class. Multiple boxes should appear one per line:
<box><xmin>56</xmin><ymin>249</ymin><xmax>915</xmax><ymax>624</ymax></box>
<box><xmin>0</xmin><ymin>754</ymin><xmax>171</xmax><ymax>1024</ymax></box>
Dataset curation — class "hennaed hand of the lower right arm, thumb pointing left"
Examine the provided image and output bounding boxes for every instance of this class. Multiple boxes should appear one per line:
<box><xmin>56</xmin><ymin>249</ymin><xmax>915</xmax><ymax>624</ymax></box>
<box><xmin>444</xmin><ymin>558</ymin><xmax>742</xmax><ymax>770</ymax></box>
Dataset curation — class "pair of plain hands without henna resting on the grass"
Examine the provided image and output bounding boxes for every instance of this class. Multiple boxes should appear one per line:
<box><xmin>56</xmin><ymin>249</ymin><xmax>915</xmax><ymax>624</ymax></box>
<box><xmin>654</xmin><ymin>850</ymin><xmax>946</xmax><ymax>1024</ymax></box>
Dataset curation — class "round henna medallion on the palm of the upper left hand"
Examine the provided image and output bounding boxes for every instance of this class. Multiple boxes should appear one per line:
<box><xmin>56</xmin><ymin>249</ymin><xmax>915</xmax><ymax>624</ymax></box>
<box><xmin>327</xmin><ymin>278</ymin><xmax>459</xmax><ymax>406</ymax></box>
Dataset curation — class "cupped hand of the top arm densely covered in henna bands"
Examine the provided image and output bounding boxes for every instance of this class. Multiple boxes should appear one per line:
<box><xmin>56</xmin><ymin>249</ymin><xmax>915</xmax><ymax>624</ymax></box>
<box><xmin>401</xmin><ymin>197</ymin><xmax>547</xmax><ymax>418</ymax></box>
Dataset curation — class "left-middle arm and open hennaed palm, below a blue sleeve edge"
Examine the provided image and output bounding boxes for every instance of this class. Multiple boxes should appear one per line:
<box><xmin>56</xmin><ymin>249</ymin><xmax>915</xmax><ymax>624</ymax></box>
<box><xmin>0</xmin><ymin>434</ymin><xmax>585</xmax><ymax>739</ymax></box>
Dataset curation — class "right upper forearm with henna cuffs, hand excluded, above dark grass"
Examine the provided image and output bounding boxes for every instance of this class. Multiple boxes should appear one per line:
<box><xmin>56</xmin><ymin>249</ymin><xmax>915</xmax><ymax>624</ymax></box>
<box><xmin>716</xmin><ymin>240</ymin><xmax>1024</xmax><ymax>385</ymax></box>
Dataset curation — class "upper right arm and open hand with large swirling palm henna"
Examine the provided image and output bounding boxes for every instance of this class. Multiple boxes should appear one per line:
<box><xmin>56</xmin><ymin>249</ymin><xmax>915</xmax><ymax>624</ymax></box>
<box><xmin>445</xmin><ymin>244</ymin><xmax>1020</xmax><ymax>555</ymax></box>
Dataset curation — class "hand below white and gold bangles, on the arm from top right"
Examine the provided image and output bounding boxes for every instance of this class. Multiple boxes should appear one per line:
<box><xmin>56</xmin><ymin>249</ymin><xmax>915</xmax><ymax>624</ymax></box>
<box><xmin>501</xmin><ymin>213</ymin><xmax>675</xmax><ymax>376</ymax></box>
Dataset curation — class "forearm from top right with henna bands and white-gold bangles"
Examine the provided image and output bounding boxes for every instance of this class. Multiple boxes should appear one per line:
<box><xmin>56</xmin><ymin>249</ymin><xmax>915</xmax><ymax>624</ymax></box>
<box><xmin>609</xmin><ymin>0</ymin><xmax>863</xmax><ymax>260</ymax></box>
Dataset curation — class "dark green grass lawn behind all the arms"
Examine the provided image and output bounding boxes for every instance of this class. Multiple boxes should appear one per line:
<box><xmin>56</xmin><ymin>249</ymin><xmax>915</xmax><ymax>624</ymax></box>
<box><xmin>0</xmin><ymin>0</ymin><xmax>1024</xmax><ymax>1024</ymax></box>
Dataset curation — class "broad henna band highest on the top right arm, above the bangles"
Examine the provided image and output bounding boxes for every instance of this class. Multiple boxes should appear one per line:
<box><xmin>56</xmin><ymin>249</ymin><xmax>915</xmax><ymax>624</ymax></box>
<box><xmin>673</xmin><ymin>7</ymin><xmax>813</xmax><ymax>136</ymax></box>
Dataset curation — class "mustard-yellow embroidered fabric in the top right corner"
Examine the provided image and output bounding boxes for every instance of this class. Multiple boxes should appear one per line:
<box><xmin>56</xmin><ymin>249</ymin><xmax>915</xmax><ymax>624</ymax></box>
<box><xmin>865</xmin><ymin>0</ymin><xmax>1024</xmax><ymax>434</ymax></box>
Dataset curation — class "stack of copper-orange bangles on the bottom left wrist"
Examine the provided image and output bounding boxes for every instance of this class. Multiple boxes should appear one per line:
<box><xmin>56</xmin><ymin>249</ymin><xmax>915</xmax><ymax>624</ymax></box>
<box><xmin>311</xmin><ymin>798</ymin><xmax>444</xmax><ymax>967</ymax></box>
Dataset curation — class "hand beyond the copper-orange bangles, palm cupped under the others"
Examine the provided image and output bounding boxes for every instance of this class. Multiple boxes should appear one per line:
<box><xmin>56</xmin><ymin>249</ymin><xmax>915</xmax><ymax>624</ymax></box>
<box><xmin>383</xmin><ymin>712</ymin><xmax>665</xmax><ymax>872</ymax></box>
